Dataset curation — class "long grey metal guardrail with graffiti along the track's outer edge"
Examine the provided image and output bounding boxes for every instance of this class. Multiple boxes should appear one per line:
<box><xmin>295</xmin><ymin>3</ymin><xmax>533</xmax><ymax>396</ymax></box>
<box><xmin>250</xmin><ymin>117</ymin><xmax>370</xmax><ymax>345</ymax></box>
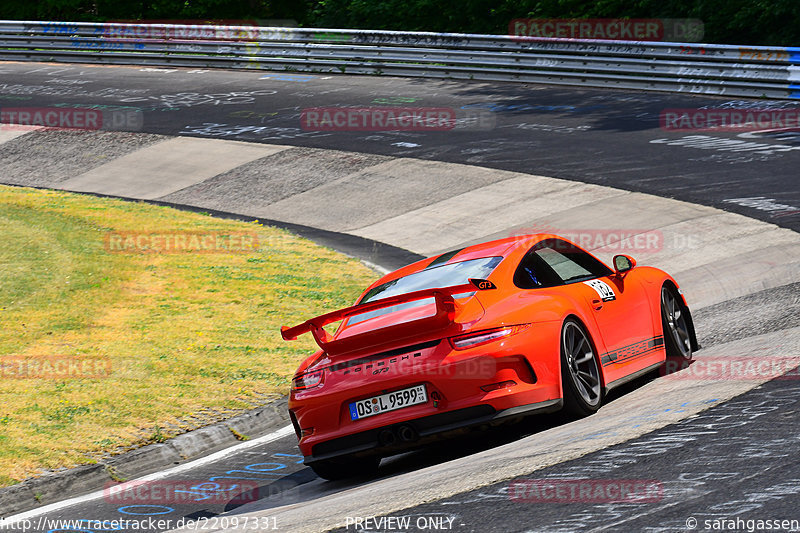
<box><xmin>0</xmin><ymin>21</ymin><xmax>800</xmax><ymax>99</ymax></box>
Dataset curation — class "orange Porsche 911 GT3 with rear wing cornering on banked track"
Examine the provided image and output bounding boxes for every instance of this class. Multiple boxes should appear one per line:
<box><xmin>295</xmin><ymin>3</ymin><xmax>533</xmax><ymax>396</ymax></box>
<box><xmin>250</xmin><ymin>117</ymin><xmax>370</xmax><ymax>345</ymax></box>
<box><xmin>281</xmin><ymin>234</ymin><xmax>698</xmax><ymax>479</ymax></box>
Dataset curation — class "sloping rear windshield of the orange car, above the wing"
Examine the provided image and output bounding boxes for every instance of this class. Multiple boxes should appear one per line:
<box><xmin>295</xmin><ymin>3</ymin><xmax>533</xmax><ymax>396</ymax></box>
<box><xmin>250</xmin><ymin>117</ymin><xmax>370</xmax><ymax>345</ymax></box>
<box><xmin>358</xmin><ymin>257</ymin><xmax>503</xmax><ymax>304</ymax></box>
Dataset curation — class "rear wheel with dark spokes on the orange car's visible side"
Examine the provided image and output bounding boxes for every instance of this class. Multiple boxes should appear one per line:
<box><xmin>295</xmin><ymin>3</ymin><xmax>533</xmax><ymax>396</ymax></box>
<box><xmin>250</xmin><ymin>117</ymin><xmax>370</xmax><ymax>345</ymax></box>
<box><xmin>561</xmin><ymin>318</ymin><xmax>603</xmax><ymax>417</ymax></box>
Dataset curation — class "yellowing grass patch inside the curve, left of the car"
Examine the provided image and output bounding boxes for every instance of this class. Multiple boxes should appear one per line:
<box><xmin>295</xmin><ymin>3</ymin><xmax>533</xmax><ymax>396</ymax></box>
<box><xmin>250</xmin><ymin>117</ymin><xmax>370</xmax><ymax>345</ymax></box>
<box><xmin>0</xmin><ymin>186</ymin><xmax>376</xmax><ymax>486</ymax></box>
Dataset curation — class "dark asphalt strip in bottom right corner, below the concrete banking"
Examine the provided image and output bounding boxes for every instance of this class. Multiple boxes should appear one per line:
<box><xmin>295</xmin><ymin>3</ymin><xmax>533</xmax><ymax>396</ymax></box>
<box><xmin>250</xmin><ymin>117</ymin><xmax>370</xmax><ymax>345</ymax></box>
<box><xmin>326</xmin><ymin>370</ymin><xmax>800</xmax><ymax>533</ymax></box>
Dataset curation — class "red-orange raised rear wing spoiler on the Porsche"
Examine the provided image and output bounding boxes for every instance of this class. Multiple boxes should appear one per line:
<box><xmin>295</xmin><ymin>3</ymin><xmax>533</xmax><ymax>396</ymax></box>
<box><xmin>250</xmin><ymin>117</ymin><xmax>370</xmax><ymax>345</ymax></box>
<box><xmin>281</xmin><ymin>279</ymin><xmax>496</xmax><ymax>355</ymax></box>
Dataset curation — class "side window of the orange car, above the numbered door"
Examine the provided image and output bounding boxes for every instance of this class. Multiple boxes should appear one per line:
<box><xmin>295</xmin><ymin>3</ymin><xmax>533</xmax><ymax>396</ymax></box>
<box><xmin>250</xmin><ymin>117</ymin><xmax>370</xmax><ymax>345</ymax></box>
<box><xmin>514</xmin><ymin>239</ymin><xmax>611</xmax><ymax>289</ymax></box>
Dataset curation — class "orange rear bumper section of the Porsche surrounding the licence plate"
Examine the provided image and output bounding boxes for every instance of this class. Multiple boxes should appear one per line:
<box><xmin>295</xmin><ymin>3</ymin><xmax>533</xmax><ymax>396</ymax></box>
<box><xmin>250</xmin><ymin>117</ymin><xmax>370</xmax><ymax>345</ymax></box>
<box><xmin>289</xmin><ymin>322</ymin><xmax>562</xmax><ymax>460</ymax></box>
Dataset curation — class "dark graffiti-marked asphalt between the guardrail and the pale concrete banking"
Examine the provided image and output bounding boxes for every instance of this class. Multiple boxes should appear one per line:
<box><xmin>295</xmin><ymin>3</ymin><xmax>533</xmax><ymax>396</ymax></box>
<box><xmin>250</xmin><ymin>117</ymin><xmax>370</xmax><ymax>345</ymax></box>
<box><xmin>0</xmin><ymin>63</ymin><xmax>800</xmax><ymax>231</ymax></box>
